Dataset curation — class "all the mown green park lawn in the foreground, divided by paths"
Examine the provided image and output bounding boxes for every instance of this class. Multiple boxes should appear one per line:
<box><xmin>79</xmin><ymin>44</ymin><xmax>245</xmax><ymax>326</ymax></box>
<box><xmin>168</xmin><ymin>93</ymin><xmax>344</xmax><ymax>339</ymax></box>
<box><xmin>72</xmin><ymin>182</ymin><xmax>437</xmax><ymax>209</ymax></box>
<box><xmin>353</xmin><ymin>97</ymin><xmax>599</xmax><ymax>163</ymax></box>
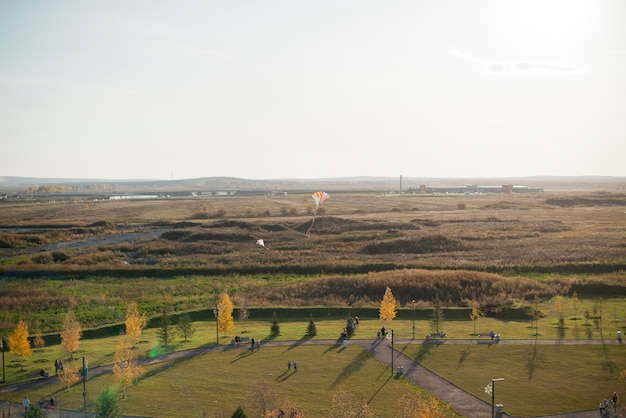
<box><xmin>6</xmin><ymin>308</ymin><xmax>626</xmax><ymax>417</ymax></box>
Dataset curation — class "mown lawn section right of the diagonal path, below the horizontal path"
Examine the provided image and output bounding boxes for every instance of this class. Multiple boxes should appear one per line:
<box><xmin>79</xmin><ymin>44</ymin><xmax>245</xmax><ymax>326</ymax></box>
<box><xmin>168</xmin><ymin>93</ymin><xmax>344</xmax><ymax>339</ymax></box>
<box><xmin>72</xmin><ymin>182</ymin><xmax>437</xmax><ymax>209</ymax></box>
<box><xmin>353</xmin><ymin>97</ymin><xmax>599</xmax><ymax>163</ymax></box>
<box><xmin>400</xmin><ymin>343</ymin><xmax>626</xmax><ymax>417</ymax></box>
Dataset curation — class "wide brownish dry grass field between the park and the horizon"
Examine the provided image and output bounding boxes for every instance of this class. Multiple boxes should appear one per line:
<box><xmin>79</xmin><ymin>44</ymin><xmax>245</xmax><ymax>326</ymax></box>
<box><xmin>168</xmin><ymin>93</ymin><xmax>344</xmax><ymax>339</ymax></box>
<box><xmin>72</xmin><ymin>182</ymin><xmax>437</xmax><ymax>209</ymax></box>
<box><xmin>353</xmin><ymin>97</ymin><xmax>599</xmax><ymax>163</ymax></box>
<box><xmin>0</xmin><ymin>191</ymin><xmax>626</xmax><ymax>331</ymax></box>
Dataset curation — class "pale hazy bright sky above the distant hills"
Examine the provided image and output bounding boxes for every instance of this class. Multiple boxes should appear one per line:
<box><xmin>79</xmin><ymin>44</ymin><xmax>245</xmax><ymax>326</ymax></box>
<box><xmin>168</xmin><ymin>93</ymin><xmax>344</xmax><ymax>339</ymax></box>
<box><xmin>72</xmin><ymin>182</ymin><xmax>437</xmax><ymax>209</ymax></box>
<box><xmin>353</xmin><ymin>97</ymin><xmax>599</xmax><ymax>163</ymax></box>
<box><xmin>0</xmin><ymin>0</ymin><xmax>626</xmax><ymax>180</ymax></box>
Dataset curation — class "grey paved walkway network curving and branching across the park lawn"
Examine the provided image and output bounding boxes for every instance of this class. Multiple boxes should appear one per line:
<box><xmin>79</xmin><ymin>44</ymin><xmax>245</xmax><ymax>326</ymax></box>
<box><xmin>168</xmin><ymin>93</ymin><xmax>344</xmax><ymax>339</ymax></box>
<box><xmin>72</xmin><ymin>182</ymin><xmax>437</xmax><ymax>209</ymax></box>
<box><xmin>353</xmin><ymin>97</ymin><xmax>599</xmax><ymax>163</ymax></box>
<box><xmin>0</xmin><ymin>339</ymin><xmax>622</xmax><ymax>418</ymax></box>
